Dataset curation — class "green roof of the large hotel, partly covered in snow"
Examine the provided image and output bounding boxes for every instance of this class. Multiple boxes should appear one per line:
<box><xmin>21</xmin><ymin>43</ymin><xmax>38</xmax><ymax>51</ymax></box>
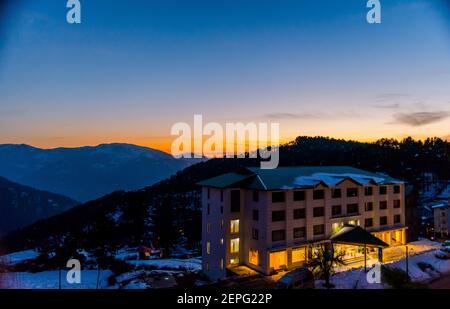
<box><xmin>199</xmin><ymin>166</ymin><xmax>403</xmax><ymax>190</ymax></box>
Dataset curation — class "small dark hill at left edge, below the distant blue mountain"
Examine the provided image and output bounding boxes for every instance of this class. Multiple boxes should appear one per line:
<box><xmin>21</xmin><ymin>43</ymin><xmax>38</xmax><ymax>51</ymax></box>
<box><xmin>0</xmin><ymin>177</ymin><xmax>79</xmax><ymax>234</ymax></box>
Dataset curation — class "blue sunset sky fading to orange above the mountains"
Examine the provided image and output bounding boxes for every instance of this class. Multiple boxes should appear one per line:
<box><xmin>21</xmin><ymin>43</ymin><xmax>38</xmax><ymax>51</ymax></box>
<box><xmin>0</xmin><ymin>0</ymin><xmax>450</xmax><ymax>151</ymax></box>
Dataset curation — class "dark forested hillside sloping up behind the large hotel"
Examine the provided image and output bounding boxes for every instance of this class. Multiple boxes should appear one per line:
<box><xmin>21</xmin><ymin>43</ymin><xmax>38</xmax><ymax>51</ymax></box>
<box><xmin>1</xmin><ymin>137</ymin><xmax>450</xmax><ymax>251</ymax></box>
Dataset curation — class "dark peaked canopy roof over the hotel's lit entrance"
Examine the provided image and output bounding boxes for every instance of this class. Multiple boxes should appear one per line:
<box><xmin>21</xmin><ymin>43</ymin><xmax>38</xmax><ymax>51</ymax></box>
<box><xmin>330</xmin><ymin>225</ymin><xmax>389</xmax><ymax>247</ymax></box>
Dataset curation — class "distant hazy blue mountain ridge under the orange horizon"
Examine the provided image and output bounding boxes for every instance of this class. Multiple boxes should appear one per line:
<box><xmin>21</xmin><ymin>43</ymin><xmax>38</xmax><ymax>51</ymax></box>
<box><xmin>0</xmin><ymin>143</ymin><xmax>202</xmax><ymax>201</ymax></box>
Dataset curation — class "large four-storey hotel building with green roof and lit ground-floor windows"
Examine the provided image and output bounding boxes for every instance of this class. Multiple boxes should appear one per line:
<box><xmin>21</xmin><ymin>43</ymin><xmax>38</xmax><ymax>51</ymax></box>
<box><xmin>200</xmin><ymin>167</ymin><xmax>406</xmax><ymax>279</ymax></box>
